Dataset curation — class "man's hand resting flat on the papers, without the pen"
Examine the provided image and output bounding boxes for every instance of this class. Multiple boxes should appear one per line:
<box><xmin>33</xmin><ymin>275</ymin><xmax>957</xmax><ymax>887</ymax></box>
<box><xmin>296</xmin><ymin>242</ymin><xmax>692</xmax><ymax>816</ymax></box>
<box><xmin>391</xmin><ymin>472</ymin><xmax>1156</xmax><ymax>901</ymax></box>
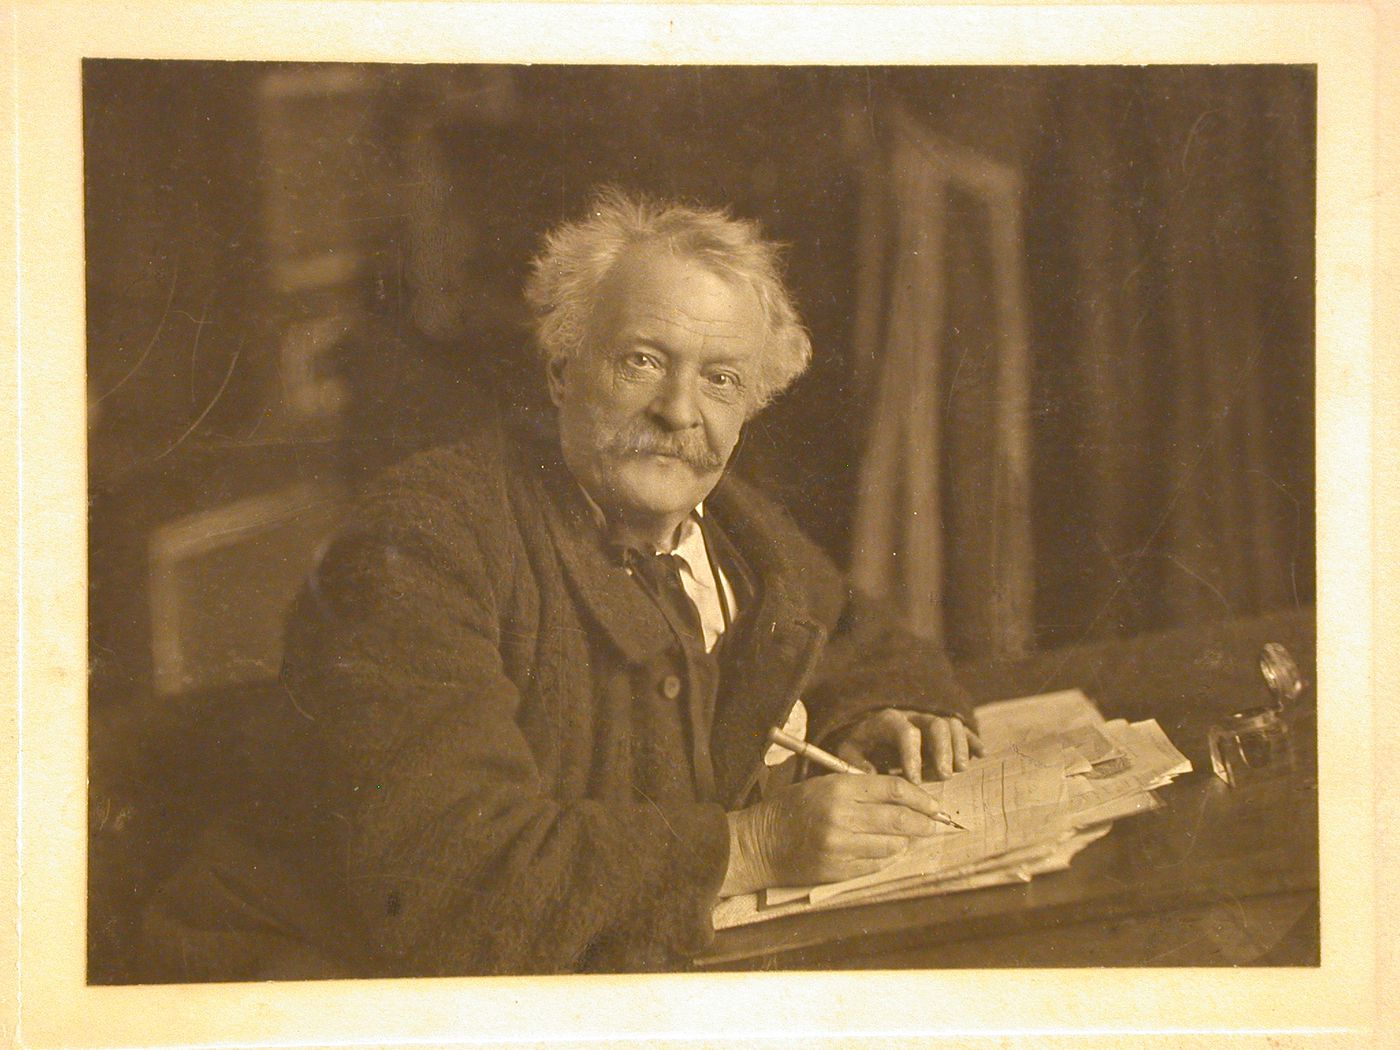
<box><xmin>836</xmin><ymin>707</ymin><xmax>981</xmax><ymax>784</ymax></box>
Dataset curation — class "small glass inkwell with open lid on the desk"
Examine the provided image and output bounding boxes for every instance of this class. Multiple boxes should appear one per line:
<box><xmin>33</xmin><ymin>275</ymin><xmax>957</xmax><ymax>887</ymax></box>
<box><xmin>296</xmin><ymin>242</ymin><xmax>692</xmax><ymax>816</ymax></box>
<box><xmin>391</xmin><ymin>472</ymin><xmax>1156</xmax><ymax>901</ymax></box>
<box><xmin>1210</xmin><ymin>641</ymin><xmax>1308</xmax><ymax>787</ymax></box>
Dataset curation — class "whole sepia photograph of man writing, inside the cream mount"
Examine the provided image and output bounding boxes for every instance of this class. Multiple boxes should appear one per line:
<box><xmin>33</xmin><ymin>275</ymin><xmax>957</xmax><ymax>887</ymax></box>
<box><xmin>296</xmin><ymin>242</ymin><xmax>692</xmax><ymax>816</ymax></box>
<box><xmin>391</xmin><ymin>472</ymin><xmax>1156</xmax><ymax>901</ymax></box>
<box><xmin>83</xmin><ymin>59</ymin><xmax>1326</xmax><ymax>984</ymax></box>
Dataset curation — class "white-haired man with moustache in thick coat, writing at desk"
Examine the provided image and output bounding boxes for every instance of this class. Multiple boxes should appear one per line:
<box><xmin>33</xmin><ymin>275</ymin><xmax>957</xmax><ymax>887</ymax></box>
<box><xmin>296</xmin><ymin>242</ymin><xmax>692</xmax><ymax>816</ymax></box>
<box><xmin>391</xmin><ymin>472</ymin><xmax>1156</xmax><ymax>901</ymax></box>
<box><xmin>148</xmin><ymin>192</ymin><xmax>977</xmax><ymax>977</ymax></box>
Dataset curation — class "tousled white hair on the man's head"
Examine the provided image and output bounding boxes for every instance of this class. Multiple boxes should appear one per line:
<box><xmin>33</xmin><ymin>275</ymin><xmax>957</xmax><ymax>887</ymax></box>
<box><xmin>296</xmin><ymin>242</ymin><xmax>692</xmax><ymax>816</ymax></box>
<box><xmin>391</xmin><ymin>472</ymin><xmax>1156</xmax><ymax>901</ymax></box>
<box><xmin>525</xmin><ymin>188</ymin><xmax>812</xmax><ymax>412</ymax></box>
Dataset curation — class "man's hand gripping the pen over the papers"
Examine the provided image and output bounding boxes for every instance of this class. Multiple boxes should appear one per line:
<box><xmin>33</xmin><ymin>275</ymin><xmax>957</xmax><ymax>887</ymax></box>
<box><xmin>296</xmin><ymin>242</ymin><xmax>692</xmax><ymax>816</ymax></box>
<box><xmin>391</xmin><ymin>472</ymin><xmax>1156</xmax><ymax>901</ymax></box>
<box><xmin>721</xmin><ymin>773</ymin><xmax>941</xmax><ymax>896</ymax></box>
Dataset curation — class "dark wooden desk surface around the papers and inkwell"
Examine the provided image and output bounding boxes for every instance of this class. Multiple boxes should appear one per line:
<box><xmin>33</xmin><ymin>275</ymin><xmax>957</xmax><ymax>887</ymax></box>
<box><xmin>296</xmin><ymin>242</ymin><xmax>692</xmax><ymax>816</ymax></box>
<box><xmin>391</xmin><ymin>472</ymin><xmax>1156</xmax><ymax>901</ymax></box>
<box><xmin>701</xmin><ymin>609</ymin><xmax>1319</xmax><ymax>969</ymax></box>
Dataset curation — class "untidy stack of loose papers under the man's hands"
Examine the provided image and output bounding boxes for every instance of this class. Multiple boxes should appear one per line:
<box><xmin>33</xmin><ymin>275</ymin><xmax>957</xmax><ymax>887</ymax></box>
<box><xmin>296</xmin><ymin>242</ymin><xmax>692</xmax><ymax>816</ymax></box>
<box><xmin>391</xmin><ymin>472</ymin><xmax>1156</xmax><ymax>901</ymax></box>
<box><xmin>714</xmin><ymin>690</ymin><xmax>1191</xmax><ymax>930</ymax></box>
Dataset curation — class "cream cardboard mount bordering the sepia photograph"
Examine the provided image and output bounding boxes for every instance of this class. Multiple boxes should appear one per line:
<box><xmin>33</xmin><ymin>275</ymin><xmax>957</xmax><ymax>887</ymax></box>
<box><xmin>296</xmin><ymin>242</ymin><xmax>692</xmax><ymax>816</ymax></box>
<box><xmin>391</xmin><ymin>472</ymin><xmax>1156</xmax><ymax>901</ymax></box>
<box><xmin>4</xmin><ymin>1</ymin><xmax>1397</xmax><ymax>1047</ymax></box>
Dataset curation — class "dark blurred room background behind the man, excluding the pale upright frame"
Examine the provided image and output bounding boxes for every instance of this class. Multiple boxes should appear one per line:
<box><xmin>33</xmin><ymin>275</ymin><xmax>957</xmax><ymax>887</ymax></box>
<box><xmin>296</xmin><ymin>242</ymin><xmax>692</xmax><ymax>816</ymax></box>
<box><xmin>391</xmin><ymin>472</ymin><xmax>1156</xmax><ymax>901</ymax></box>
<box><xmin>84</xmin><ymin>60</ymin><xmax>1315</xmax><ymax>977</ymax></box>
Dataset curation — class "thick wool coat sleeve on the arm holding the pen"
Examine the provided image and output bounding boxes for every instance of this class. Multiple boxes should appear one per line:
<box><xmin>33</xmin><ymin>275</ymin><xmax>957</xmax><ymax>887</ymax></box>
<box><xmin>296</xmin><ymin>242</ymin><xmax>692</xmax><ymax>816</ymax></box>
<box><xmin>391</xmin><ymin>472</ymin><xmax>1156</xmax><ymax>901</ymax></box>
<box><xmin>284</xmin><ymin>484</ymin><xmax>728</xmax><ymax>976</ymax></box>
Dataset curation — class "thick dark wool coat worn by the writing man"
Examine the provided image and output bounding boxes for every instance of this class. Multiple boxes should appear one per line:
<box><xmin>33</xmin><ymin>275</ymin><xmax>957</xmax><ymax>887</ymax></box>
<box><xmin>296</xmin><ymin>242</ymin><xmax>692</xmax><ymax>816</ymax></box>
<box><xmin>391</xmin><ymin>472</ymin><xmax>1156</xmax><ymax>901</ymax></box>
<box><xmin>147</xmin><ymin>408</ymin><xmax>966</xmax><ymax>980</ymax></box>
